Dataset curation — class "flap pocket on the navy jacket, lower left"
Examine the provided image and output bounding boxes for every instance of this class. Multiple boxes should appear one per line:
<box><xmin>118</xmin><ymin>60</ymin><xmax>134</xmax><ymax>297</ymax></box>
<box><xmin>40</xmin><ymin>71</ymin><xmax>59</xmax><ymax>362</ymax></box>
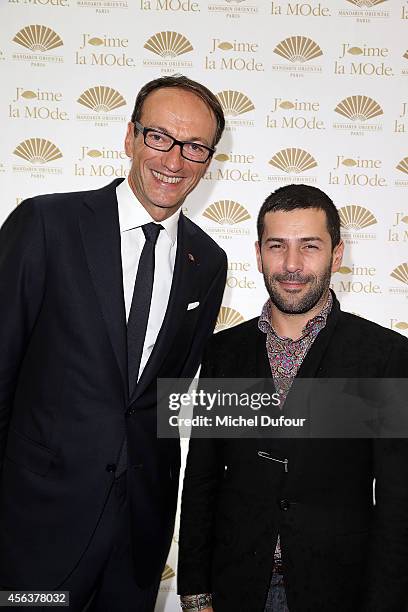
<box><xmin>6</xmin><ymin>429</ymin><xmax>56</xmax><ymax>476</ymax></box>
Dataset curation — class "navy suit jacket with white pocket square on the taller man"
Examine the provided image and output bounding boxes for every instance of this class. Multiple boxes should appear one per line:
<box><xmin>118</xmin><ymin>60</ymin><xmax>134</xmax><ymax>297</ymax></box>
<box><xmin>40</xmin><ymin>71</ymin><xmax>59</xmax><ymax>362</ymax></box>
<box><xmin>0</xmin><ymin>181</ymin><xmax>226</xmax><ymax>589</ymax></box>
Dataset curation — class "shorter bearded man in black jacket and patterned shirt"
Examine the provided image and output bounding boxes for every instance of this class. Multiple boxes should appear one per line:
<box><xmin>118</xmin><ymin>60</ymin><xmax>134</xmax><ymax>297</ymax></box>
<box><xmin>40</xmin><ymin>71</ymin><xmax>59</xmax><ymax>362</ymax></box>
<box><xmin>178</xmin><ymin>185</ymin><xmax>408</xmax><ymax>612</ymax></box>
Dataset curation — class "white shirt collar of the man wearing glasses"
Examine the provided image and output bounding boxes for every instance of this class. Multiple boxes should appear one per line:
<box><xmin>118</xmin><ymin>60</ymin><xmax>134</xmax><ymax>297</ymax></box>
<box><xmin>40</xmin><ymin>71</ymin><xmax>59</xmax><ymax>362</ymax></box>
<box><xmin>116</xmin><ymin>179</ymin><xmax>181</xmax><ymax>244</ymax></box>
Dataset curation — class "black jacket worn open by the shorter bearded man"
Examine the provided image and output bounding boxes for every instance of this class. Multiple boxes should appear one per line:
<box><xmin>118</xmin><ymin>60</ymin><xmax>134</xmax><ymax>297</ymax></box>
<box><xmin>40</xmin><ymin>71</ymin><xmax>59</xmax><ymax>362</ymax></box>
<box><xmin>178</xmin><ymin>300</ymin><xmax>408</xmax><ymax>612</ymax></box>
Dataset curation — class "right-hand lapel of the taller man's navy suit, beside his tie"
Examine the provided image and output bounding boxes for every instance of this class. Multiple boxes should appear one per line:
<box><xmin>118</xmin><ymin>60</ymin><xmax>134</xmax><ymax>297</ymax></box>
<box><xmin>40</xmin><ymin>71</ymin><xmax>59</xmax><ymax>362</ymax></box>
<box><xmin>130</xmin><ymin>213</ymin><xmax>199</xmax><ymax>402</ymax></box>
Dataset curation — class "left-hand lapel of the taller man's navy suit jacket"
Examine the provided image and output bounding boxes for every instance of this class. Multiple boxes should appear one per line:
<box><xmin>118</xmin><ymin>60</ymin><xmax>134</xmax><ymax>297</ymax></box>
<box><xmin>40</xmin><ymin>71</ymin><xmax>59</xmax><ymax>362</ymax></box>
<box><xmin>80</xmin><ymin>181</ymin><xmax>128</xmax><ymax>390</ymax></box>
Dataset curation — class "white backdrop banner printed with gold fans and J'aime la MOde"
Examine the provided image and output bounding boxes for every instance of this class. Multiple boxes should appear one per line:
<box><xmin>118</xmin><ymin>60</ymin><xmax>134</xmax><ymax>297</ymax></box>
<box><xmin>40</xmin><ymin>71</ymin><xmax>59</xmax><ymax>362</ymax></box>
<box><xmin>0</xmin><ymin>0</ymin><xmax>408</xmax><ymax>612</ymax></box>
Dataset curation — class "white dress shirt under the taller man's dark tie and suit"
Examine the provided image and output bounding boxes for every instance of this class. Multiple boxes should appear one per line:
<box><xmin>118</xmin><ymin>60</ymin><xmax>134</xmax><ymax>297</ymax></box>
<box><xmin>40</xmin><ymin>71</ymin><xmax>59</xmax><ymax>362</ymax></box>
<box><xmin>116</xmin><ymin>175</ymin><xmax>180</xmax><ymax>379</ymax></box>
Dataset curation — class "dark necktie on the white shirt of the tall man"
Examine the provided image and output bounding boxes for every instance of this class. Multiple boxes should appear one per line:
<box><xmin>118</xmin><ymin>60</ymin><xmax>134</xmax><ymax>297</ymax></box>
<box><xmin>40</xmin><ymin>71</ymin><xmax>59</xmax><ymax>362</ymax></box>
<box><xmin>127</xmin><ymin>223</ymin><xmax>163</xmax><ymax>397</ymax></box>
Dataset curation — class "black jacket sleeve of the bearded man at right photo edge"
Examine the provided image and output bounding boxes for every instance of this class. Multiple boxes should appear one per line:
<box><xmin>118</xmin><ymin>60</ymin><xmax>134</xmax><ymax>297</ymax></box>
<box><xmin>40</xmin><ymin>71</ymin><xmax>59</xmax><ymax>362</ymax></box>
<box><xmin>362</xmin><ymin>338</ymin><xmax>408</xmax><ymax>612</ymax></box>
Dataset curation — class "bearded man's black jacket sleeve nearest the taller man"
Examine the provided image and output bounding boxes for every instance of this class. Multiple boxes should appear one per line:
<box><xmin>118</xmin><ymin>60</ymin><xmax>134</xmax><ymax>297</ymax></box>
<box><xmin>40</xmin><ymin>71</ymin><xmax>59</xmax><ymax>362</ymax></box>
<box><xmin>177</xmin><ymin>341</ymin><xmax>224</xmax><ymax>595</ymax></box>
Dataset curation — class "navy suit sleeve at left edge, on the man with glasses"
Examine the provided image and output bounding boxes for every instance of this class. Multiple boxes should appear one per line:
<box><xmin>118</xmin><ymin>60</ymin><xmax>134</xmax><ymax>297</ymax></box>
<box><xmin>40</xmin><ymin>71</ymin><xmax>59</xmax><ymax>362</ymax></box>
<box><xmin>0</xmin><ymin>200</ymin><xmax>45</xmax><ymax>466</ymax></box>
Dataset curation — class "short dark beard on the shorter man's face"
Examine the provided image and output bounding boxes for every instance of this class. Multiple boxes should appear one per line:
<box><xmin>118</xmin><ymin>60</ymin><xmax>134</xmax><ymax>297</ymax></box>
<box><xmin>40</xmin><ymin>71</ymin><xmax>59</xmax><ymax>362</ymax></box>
<box><xmin>264</xmin><ymin>259</ymin><xmax>332</xmax><ymax>315</ymax></box>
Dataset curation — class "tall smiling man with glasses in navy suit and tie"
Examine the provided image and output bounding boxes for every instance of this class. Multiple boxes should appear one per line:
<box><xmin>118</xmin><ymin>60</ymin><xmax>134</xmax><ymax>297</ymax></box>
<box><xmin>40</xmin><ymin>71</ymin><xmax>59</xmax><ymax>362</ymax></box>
<box><xmin>0</xmin><ymin>76</ymin><xmax>226</xmax><ymax>612</ymax></box>
